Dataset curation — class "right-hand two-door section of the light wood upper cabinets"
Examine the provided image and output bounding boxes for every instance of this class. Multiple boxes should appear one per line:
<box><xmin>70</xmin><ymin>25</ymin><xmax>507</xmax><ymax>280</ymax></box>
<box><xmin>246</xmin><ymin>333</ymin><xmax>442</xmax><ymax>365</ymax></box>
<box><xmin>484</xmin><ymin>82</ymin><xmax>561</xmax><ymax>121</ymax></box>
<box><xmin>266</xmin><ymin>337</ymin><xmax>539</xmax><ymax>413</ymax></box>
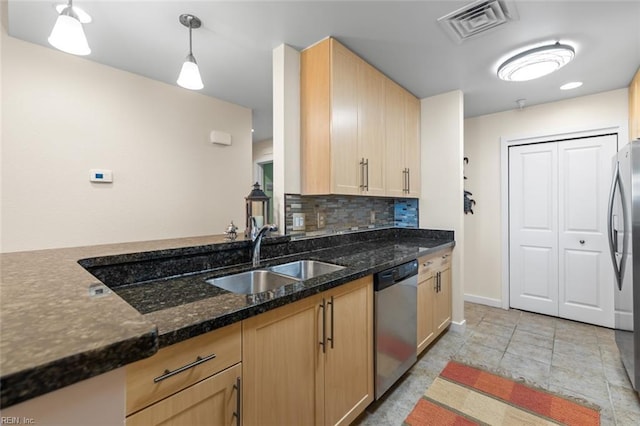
<box><xmin>384</xmin><ymin>79</ymin><xmax>420</xmax><ymax>198</ymax></box>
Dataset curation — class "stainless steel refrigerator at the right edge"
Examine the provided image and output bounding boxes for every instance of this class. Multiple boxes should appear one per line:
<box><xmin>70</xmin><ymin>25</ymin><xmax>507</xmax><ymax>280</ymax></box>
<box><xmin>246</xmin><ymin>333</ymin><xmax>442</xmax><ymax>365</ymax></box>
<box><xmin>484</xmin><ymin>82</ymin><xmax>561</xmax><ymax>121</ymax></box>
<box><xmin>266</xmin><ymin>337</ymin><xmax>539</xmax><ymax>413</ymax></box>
<box><xmin>608</xmin><ymin>140</ymin><xmax>640</xmax><ymax>392</ymax></box>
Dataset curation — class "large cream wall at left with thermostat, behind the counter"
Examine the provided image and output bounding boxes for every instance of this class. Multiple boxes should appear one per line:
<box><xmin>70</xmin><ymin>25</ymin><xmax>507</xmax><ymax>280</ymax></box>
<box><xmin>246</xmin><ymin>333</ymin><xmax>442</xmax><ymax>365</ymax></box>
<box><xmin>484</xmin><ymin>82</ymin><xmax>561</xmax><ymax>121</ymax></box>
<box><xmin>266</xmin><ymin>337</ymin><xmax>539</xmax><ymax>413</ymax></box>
<box><xmin>0</xmin><ymin>35</ymin><xmax>252</xmax><ymax>252</ymax></box>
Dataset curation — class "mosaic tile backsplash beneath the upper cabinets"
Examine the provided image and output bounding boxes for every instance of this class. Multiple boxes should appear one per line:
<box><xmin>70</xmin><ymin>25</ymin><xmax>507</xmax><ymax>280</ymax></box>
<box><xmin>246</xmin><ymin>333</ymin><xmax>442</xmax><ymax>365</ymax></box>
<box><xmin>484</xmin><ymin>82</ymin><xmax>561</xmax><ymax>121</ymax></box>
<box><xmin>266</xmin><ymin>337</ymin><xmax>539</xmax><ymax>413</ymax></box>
<box><xmin>285</xmin><ymin>194</ymin><xmax>418</xmax><ymax>235</ymax></box>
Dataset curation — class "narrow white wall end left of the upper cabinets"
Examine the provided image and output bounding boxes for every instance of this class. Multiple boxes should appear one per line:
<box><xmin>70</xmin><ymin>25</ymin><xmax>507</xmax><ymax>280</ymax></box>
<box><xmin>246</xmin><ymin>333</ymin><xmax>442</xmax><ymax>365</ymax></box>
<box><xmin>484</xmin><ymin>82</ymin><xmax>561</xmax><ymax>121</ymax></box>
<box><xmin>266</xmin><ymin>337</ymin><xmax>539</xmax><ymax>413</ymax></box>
<box><xmin>273</xmin><ymin>44</ymin><xmax>300</xmax><ymax>230</ymax></box>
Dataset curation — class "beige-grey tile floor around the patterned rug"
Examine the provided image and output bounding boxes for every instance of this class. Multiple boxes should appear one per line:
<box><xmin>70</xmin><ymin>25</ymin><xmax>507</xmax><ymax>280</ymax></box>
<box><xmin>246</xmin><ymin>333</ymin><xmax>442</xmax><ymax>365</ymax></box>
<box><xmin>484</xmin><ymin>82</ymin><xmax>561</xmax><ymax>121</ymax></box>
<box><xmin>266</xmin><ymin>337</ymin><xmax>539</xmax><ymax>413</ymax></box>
<box><xmin>354</xmin><ymin>303</ymin><xmax>640</xmax><ymax>426</ymax></box>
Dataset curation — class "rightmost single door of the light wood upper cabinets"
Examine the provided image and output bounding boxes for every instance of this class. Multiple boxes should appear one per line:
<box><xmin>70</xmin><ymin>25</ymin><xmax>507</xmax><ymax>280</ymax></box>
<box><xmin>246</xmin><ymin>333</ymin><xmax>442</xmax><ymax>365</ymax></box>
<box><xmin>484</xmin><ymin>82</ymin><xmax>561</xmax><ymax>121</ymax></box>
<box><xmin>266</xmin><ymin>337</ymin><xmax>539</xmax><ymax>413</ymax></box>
<box><xmin>404</xmin><ymin>92</ymin><xmax>420</xmax><ymax>198</ymax></box>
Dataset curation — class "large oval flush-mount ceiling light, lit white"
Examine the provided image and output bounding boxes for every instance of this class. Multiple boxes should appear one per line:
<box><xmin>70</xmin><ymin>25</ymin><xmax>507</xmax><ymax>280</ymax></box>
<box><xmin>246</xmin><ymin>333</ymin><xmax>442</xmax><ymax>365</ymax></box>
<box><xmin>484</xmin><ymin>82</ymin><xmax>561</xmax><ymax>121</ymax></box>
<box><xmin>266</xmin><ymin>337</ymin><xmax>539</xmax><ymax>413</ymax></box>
<box><xmin>498</xmin><ymin>43</ymin><xmax>575</xmax><ymax>81</ymax></box>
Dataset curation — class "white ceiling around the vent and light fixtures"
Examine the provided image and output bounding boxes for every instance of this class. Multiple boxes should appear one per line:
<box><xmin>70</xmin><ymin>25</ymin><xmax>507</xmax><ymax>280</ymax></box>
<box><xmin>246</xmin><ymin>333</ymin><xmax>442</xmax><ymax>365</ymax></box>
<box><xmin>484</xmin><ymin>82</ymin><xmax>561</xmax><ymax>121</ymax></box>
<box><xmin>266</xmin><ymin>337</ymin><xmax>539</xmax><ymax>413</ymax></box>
<box><xmin>8</xmin><ymin>0</ymin><xmax>640</xmax><ymax>141</ymax></box>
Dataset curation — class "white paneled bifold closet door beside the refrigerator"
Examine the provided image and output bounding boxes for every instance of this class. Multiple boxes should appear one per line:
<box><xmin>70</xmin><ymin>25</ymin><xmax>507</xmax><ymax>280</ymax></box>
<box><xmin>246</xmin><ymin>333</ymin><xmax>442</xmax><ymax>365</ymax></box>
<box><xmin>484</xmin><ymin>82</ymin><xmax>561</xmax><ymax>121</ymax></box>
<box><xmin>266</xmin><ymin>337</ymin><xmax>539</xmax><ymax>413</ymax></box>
<box><xmin>509</xmin><ymin>135</ymin><xmax>617</xmax><ymax>327</ymax></box>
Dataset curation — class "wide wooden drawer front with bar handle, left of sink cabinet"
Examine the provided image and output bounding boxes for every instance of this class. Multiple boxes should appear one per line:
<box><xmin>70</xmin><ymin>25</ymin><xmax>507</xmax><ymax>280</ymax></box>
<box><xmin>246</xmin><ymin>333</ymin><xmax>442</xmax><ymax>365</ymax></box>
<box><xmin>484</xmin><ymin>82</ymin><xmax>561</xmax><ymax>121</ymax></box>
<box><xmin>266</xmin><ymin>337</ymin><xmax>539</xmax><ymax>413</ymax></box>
<box><xmin>126</xmin><ymin>323</ymin><xmax>242</xmax><ymax>415</ymax></box>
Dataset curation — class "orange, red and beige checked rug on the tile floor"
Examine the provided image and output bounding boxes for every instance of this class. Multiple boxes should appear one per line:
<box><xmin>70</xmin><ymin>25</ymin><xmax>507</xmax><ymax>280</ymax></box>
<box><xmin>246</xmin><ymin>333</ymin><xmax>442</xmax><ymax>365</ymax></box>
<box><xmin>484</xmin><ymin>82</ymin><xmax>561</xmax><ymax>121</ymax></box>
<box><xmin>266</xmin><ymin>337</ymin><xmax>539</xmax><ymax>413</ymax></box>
<box><xmin>404</xmin><ymin>361</ymin><xmax>600</xmax><ymax>426</ymax></box>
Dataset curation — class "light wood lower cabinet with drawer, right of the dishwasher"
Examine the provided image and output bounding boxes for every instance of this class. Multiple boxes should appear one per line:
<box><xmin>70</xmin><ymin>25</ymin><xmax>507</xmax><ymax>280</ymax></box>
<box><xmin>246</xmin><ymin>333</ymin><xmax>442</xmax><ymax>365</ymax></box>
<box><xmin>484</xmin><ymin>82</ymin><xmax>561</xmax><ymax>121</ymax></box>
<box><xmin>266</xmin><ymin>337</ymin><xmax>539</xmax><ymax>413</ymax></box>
<box><xmin>417</xmin><ymin>249</ymin><xmax>452</xmax><ymax>353</ymax></box>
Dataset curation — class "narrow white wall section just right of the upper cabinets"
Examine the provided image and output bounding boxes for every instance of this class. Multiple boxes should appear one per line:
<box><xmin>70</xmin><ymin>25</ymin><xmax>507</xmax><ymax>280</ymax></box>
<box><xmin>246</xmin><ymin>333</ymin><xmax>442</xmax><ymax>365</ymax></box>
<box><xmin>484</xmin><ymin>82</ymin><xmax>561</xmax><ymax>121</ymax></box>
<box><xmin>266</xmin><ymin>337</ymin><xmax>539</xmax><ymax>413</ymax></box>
<box><xmin>420</xmin><ymin>90</ymin><xmax>465</xmax><ymax>329</ymax></box>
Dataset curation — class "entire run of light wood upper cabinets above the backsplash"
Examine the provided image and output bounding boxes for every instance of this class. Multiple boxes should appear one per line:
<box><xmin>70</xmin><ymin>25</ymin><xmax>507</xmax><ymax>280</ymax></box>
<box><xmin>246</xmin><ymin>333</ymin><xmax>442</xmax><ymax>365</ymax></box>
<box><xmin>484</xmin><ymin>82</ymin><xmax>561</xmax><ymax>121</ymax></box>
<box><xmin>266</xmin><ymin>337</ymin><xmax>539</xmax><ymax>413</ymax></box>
<box><xmin>300</xmin><ymin>38</ymin><xmax>420</xmax><ymax>197</ymax></box>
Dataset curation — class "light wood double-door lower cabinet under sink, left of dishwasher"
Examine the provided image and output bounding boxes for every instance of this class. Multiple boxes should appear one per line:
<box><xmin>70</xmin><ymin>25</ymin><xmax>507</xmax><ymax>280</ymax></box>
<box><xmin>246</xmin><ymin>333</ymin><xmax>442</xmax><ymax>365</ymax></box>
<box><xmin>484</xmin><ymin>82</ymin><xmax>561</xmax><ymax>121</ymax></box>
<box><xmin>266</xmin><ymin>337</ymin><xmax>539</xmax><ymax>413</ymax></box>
<box><xmin>242</xmin><ymin>276</ymin><xmax>374</xmax><ymax>425</ymax></box>
